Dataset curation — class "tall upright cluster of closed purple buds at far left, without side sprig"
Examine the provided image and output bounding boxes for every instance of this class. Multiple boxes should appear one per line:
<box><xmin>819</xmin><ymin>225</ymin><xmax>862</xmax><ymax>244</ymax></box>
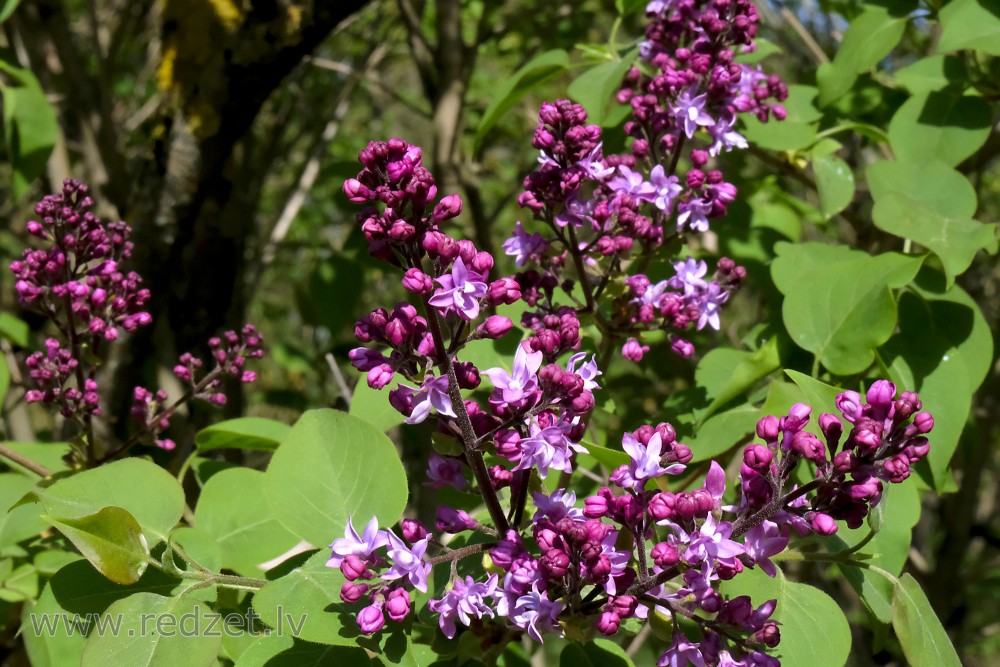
<box><xmin>10</xmin><ymin>179</ymin><xmax>152</xmax><ymax>419</ymax></box>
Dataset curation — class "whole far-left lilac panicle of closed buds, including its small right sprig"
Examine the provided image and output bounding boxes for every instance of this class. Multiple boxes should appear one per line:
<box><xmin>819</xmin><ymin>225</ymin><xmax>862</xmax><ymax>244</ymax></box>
<box><xmin>10</xmin><ymin>179</ymin><xmax>264</xmax><ymax>453</ymax></box>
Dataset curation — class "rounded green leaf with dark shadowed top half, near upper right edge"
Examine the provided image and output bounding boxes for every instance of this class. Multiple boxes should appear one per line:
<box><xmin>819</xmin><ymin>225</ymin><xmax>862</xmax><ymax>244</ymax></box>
<box><xmin>889</xmin><ymin>93</ymin><xmax>993</xmax><ymax>166</ymax></box>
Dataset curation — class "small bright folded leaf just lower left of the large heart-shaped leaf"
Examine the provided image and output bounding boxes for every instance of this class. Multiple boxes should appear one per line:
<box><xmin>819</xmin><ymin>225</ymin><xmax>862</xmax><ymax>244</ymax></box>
<box><xmin>695</xmin><ymin>336</ymin><xmax>781</xmax><ymax>419</ymax></box>
